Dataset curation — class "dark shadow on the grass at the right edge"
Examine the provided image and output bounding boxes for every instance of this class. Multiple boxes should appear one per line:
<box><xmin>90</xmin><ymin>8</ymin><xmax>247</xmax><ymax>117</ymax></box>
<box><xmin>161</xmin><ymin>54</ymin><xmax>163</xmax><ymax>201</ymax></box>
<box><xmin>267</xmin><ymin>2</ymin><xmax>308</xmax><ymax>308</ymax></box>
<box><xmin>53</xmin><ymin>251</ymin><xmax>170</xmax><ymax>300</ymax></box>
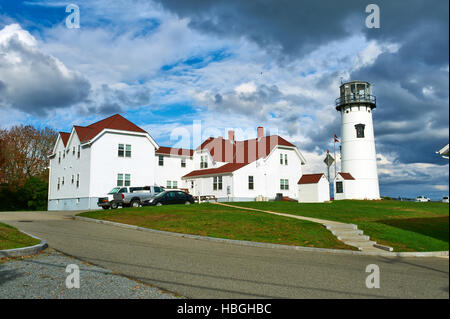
<box><xmin>377</xmin><ymin>216</ymin><xmax>449</xmax><ymax>243</ymax></box>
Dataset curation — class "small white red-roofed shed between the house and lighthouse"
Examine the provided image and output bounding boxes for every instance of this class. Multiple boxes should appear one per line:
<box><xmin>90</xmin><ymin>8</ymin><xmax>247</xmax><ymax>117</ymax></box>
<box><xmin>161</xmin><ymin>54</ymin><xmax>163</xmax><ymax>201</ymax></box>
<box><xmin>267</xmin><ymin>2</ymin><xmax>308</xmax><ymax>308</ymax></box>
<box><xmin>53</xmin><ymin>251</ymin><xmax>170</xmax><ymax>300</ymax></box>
<box><xmin>298</xmin><ymin>173</ymin><xmax>330</xmax><ymax>203</ymax></box>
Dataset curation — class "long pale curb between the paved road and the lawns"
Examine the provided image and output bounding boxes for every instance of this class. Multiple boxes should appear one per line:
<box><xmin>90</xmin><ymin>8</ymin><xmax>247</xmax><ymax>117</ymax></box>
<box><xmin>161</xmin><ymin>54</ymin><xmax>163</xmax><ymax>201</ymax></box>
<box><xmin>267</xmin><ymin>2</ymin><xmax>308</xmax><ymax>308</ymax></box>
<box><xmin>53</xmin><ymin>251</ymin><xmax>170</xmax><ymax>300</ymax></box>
<box><xmin>74</xmin><ymin>216</ymin><xmax>449</xmax><ymax>257</ymax></box>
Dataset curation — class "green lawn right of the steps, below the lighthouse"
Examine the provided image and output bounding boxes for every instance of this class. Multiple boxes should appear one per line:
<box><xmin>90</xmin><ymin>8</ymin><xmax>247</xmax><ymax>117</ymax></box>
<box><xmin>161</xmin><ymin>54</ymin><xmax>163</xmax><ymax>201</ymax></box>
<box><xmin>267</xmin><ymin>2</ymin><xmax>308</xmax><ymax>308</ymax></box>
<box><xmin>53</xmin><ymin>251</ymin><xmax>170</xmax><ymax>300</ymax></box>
<box><xmin>232</xmin><ymin>200</ymin><xmax>449</xmax><ymax>251</ymax></box>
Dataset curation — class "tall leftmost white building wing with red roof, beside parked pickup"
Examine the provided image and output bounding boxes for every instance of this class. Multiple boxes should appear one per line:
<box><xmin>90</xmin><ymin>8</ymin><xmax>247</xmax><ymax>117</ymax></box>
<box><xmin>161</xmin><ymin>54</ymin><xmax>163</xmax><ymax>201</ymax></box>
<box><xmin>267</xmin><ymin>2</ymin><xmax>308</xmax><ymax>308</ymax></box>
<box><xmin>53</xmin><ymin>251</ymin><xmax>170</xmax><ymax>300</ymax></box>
<box><xmin>48</xmin><ymin>115</ymin><xmax>158</xmax><ymax>210</ymax></box>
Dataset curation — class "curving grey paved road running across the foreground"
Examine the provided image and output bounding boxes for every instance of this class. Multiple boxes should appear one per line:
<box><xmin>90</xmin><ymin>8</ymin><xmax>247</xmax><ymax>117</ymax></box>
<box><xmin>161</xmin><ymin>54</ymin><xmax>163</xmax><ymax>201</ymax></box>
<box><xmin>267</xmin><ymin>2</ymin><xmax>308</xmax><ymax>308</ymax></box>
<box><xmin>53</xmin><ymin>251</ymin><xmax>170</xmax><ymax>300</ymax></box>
<box><xmin>0</xmin><ymin>212</ymin><xmax>449</xmax><ymax>299</ymax></box>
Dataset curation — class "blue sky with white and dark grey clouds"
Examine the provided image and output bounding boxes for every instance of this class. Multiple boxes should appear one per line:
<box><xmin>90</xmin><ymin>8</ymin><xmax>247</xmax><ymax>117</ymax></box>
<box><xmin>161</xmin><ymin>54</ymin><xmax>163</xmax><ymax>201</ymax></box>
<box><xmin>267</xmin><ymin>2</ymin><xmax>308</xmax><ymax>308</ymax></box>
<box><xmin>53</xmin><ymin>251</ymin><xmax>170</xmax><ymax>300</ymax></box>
<box><xmin>0</xmin><ymin>0</ymin><xmax>449</xmax><ymax>198</ymax></box>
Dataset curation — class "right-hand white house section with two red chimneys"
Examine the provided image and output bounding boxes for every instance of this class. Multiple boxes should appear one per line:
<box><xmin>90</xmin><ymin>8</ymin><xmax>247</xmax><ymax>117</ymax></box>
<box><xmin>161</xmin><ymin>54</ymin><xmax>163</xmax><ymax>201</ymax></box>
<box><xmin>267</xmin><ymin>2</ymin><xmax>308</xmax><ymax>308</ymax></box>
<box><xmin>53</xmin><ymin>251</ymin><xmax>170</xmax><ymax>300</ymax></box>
<box><xmin>183</xmin><ymin>127</ymin><xmax>306</xmax><ymax>201</ymax></box>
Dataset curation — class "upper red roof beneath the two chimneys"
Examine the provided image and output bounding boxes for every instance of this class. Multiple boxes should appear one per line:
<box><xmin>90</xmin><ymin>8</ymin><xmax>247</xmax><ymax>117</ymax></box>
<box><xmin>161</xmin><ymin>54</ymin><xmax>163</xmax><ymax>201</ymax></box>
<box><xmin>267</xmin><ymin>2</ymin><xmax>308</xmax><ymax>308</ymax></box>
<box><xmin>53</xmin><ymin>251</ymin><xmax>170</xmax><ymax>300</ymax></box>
<box><xmin>197</xmin><ymin>135</ymin><xmax>296</xmax><ymax>164</ymax></box>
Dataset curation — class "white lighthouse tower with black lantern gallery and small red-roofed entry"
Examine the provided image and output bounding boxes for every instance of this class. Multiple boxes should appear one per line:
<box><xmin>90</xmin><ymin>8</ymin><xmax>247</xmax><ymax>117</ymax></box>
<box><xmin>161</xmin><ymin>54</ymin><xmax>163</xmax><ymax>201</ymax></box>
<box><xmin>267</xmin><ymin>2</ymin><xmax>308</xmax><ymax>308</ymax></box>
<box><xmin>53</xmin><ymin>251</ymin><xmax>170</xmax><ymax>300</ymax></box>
<box><xmin>334</xmin><ymin>81</ymin><xmax>380</xmax><ymax>199</ymax></box>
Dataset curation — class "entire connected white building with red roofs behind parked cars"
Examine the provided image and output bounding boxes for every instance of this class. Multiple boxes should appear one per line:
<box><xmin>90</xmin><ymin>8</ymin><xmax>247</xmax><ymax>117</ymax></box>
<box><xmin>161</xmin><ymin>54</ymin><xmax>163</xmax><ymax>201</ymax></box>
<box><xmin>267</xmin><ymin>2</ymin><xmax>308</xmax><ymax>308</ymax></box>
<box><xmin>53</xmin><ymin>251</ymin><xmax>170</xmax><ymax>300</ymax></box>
<box><xmin>48</xmin><ymin>114</ymin><xmax>306</xmax><ymax>210</ymax></box>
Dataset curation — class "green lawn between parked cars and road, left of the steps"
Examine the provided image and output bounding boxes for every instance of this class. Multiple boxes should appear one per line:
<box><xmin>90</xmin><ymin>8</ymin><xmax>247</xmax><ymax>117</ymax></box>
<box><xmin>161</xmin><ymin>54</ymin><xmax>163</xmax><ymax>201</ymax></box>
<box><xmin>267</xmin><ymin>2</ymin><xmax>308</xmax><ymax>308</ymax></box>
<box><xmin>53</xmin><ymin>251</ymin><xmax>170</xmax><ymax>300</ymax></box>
<box><xmin>79</xmin><ymin>203</ymin><xmax>355</xmax><ymax>250</ymax></box>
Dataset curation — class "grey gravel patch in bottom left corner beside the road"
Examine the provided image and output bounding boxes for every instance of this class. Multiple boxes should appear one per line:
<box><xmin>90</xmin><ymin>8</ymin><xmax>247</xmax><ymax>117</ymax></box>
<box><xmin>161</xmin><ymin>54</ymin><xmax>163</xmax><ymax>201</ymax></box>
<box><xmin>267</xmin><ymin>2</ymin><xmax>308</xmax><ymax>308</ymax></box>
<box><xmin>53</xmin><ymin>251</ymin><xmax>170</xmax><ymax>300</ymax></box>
<box><xmin>0</xmin><ymin>249</ymin><xmax>176</xmax><ymax>299</ymax></box>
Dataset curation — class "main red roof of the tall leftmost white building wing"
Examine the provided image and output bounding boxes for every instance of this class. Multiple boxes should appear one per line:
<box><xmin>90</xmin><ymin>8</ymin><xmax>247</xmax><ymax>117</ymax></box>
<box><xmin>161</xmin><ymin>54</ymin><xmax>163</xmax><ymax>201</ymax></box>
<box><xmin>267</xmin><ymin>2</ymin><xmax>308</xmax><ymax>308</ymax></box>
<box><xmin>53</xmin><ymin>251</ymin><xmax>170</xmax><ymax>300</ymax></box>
<box><xmin>74</xmin><ymin>114</ymin><xmax>147</xmax><ymax>143</ymax></box>
